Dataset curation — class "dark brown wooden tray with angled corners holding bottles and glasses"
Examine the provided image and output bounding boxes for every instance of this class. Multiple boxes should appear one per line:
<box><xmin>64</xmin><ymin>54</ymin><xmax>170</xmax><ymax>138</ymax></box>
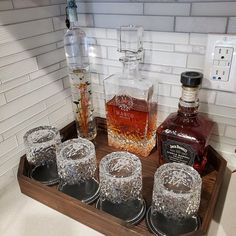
<box><xmin>18</xmin><ymin>118</ymin><xmax>226</xmax><ymax>236</ymax></box>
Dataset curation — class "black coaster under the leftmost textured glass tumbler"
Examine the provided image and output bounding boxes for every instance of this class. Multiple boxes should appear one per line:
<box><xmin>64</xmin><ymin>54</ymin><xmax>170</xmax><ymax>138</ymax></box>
<box><xmin>30</xmin><ymin>163</ymin><xmax>60</xmax><ymax>185</ymax></box>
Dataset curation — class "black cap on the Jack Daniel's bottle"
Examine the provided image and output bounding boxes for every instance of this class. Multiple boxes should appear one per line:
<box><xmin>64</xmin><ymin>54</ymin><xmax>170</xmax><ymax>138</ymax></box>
<box><xmin>180</xmin><ymin>71</ymin><xmax>203</xmax><ymax>87</ymax></box>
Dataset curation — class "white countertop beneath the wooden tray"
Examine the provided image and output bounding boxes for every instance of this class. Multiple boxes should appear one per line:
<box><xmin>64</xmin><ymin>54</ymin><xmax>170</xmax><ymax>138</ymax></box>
<box><xmin>0</xmin><ymin>156</ymin><xmax>236</xmax><ymax>236</ymax></box>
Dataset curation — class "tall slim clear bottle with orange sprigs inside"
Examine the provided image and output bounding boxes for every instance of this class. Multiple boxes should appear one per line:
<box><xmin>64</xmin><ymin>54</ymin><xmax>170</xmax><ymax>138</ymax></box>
<box><xmin>64</xmin><ymin>0</ymin><xmax>97</xmax><ymax>140</ymax></box>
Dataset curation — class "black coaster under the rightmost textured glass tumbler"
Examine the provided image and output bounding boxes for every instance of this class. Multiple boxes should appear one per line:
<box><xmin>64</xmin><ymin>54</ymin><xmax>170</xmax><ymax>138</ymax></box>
<box><xmin>146</xmin><ymin>207</ymin><xmax>201</xmax><ymax>236</ymax></box>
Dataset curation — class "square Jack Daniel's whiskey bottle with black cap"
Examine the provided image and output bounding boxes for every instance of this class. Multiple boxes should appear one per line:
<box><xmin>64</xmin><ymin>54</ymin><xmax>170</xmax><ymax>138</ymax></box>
<box><xmin>157</xmin><ymin>71</ymin><xmax>214</xmax><ymax>173</ymax></box>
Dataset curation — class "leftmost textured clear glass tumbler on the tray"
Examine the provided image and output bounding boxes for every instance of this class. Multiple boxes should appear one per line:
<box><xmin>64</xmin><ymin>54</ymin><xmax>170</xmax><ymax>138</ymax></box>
<box><xmin>23</xmin><ymin>126</ymin><xmax>61</xmax><ymax>166</ymax></box>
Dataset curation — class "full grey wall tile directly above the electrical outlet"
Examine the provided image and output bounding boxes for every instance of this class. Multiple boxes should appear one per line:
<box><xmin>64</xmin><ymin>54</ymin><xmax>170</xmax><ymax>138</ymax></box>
<box><xmin>175</xmin><ymin>17</ymin><xmax>227</xmax><ymax>33</ymax></box>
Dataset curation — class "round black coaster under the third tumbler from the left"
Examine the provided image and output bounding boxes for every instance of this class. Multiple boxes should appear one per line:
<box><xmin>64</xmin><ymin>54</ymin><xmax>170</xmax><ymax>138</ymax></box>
<box><xmin>96</xmin><ymin>197</ymin><xmax>146</xmax><ymax>225</ymax></box>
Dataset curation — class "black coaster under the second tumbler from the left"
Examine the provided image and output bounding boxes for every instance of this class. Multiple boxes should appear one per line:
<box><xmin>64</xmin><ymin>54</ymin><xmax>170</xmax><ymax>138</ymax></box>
<box><xmin>58</xmin><ymin>179</ymin><xmax>99</xmax><ymax>204</ymax></box>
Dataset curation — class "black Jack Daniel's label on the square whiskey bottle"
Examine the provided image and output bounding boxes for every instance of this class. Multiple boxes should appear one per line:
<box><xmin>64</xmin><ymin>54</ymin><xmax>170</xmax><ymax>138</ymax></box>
<box><xmin>162</xmin><ymin>140</ymin><xmax>197</xmax><ymax>166</ymax></box>
